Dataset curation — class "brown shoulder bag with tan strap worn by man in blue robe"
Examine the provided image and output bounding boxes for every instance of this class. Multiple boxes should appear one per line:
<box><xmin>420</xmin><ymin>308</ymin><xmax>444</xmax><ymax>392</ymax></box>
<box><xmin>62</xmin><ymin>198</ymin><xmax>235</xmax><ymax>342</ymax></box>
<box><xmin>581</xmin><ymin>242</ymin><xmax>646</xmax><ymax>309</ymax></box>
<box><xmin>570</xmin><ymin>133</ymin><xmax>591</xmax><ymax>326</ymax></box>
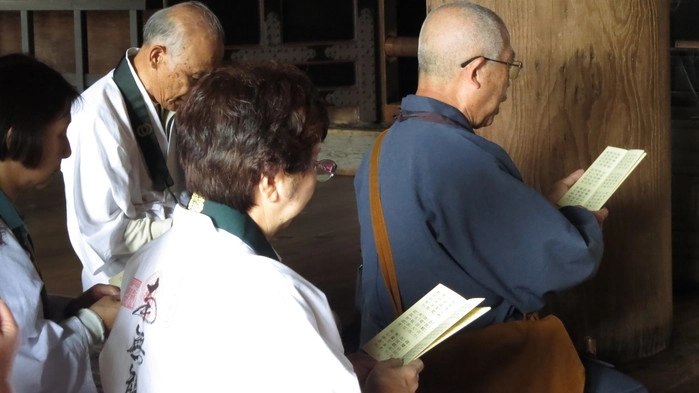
<box><xmin>369</xmin><ymin>131</ymin><xmax>585</xmax><ymax>393</ymax></box>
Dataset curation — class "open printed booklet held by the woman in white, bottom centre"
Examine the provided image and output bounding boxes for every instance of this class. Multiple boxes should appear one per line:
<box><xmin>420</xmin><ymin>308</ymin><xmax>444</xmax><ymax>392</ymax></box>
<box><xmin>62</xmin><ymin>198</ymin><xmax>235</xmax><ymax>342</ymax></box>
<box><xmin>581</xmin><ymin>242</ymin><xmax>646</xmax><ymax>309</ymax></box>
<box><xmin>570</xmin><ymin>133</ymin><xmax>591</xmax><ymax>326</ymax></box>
<box><xmin>362</xmin><ymin>284</ymin><xmax>490</xmax><ymax>363</ymax></box>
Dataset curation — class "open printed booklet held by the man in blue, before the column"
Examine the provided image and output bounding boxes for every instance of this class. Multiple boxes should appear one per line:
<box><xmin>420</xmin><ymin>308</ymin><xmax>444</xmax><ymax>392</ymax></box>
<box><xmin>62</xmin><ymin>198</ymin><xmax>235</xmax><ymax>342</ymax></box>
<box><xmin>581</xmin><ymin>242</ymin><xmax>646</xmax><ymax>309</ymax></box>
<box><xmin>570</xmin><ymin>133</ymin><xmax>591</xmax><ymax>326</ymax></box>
<box><xmin>558</xmin><ymin>146</ymin><xmax>646</xmax><ymax>210</ymax></box>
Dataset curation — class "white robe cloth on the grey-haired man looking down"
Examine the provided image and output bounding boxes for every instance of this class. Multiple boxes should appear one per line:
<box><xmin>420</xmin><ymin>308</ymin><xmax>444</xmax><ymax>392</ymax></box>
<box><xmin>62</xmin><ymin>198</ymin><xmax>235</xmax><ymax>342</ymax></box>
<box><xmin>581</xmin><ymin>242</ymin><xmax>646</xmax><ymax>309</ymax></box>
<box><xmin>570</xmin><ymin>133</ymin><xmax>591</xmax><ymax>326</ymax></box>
<box><xmin>61</xmin><ymin>69</ymin><xmax>177</xmax><ymax>289</ymax></box>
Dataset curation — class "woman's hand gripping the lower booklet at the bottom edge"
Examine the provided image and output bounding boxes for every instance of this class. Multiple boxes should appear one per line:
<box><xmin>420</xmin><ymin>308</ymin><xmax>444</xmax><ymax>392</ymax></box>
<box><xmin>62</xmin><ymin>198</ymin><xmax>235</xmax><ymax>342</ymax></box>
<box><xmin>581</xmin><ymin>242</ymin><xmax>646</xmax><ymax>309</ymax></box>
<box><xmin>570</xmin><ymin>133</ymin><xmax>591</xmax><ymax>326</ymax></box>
<box><xmin>362</xmin><ymin>359</ymin><xmax>424</xmax><ymax>393</ymax></box>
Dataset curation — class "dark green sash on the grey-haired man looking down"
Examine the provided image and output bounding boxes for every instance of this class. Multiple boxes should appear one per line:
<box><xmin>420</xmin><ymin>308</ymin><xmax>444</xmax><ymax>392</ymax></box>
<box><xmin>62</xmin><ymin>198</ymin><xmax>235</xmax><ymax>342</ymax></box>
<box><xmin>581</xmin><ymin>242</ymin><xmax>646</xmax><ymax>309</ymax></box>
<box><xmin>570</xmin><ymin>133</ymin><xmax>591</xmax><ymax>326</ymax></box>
<box><xmin>113</xmin><ymin>56</ymin><xmax>175</xmax><ymax>191</ymax></box>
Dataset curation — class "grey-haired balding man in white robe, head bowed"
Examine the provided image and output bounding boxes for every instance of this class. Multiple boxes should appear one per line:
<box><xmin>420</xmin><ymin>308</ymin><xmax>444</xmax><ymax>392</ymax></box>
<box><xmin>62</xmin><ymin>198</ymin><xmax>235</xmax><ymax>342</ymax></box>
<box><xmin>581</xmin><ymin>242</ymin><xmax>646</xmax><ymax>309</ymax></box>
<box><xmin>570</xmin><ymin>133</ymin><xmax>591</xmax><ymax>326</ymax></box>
<box><xmin>61</xmin><ymin>2</ymin><xmax>224</xmax><ymax>288</ymax></box>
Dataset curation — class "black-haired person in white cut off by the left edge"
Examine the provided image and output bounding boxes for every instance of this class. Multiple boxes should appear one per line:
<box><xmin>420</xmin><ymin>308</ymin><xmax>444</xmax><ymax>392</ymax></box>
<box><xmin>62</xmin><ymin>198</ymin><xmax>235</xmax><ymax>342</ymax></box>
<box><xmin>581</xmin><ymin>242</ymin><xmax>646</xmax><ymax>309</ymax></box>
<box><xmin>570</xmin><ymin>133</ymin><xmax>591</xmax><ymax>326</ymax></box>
<box><xmin>0</xmin><ymin>54</ymin><xmax>119</xmax><ymax>393</ymax></box>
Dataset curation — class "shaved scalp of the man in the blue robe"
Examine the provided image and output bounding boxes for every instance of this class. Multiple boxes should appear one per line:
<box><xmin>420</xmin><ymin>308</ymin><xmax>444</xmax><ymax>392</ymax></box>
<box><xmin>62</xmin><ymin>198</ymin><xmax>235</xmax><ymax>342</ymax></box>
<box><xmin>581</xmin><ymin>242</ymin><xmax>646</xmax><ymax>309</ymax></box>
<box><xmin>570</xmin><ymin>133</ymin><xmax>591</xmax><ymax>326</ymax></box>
<box><xmin>418</xmin><ymin>1</ymin><xmax>509</xmax><ymax>82</ymax></box>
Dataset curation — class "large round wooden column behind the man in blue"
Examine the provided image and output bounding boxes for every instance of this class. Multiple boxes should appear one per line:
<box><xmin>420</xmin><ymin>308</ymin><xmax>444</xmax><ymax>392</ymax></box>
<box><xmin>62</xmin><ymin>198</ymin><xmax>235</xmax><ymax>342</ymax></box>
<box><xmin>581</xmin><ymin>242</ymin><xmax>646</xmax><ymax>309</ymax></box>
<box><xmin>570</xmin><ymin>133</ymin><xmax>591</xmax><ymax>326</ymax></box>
<box><xmin>427</xmin><ymin>0</ymin><xmax>672</xmax><ymax>361</ymax></box>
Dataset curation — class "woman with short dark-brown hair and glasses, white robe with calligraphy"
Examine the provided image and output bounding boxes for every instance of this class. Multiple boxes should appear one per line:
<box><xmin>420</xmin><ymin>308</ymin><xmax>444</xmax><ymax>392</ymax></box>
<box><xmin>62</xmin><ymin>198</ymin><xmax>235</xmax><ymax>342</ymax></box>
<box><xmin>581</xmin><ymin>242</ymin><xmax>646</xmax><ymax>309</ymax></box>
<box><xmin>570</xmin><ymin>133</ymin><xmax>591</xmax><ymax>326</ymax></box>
<box><xmin>100</xmin><ymin>64</ymin><xmax>422</xmax><ymax>393</ymax></box>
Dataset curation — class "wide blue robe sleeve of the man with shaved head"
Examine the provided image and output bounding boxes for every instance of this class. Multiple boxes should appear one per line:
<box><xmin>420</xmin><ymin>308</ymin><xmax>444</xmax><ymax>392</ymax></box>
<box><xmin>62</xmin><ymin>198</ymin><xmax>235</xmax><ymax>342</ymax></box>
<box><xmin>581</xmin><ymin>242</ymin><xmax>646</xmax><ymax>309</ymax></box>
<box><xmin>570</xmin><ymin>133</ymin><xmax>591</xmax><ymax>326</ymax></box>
<box><xmin>415</xmin><ymin>129</ymin><xmax>603</xmax><ymax>312</ymax></box>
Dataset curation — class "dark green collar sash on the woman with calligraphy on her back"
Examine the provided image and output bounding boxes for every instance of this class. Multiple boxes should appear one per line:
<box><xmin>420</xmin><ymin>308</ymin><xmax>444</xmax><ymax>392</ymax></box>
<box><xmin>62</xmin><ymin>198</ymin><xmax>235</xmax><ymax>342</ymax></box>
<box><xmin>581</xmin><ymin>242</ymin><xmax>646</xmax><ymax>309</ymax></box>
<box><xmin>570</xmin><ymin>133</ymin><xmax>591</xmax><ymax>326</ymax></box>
<box><xmin>194</xmin><ymin>196</ymin><xmax>279</xmax><ymax>261</ymax></box>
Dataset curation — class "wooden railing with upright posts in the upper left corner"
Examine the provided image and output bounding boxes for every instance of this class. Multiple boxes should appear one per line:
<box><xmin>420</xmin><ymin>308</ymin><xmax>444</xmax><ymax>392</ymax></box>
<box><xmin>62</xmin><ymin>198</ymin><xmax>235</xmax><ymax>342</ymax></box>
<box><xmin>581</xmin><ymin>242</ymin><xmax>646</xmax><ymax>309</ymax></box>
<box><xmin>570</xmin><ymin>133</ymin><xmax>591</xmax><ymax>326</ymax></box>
<box><xmin>0</xmin><ymin>0</ymin><xmax>163</xmax><ymax>91</ymax></box>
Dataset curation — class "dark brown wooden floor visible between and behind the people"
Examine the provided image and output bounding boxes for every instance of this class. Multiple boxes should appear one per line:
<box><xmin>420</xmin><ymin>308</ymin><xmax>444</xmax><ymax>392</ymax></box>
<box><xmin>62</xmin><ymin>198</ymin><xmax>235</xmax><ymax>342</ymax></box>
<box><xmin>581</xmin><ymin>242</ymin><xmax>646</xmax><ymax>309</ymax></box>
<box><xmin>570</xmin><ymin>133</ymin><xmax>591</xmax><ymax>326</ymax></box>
<box><xmin>18</xmin><ymin>175</ymin><xmax>699</xmax><ymax>393</ymax></box>
